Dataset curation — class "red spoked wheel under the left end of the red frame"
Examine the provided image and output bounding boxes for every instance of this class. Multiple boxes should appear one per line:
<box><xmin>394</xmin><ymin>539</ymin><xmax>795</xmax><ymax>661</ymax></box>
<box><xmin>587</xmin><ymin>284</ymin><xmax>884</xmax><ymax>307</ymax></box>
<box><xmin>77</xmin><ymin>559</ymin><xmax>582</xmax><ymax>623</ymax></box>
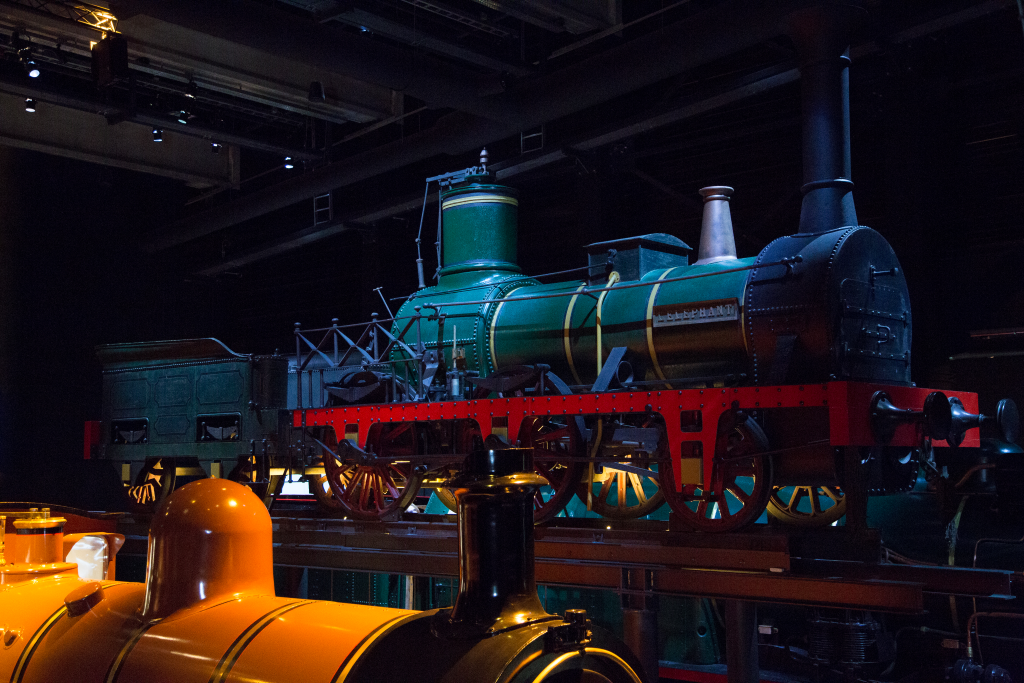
<box><xmin>324</xmin><ymin>423</ymin><xmax>423</xmax><ymax>521</ymax></box>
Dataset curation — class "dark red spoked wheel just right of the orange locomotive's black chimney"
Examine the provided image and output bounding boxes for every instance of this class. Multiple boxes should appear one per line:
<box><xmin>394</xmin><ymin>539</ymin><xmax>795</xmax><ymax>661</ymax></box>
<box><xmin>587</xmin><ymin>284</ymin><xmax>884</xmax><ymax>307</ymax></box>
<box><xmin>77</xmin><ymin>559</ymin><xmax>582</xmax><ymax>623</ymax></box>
<box><xmin>519</xmin><ymin>415</ymin><xmax>586</xmax><ymax>524</ymax></box>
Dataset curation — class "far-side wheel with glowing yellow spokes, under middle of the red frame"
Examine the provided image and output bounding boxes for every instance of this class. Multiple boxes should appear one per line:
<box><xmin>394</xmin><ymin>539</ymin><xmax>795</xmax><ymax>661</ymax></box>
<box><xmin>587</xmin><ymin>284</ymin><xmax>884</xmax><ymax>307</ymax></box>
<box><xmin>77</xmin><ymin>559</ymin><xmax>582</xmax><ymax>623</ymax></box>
<box><xmin>577</xmin><ymin>419</ymin><xmax>665</xmax><ymax>519</ymax></box>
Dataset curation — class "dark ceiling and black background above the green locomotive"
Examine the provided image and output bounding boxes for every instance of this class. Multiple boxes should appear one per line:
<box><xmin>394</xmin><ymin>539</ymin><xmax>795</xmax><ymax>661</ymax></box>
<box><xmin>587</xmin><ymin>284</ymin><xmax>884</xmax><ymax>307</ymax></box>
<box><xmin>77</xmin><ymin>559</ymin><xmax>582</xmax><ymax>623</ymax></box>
<box><xmin>0</xmin><ymin>0</ymin><xmax>1024</xmax><ymax>481</ymax></box>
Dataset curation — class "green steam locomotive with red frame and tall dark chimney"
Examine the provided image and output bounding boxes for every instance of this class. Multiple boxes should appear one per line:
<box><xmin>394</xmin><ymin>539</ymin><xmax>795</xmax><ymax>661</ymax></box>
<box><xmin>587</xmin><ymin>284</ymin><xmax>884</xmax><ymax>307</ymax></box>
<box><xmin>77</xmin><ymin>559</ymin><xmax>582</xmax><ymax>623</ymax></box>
<box><xmin>94</xmin><ymin>3</ymin><xmax>1018</xmax><ymax>531</ymax></box>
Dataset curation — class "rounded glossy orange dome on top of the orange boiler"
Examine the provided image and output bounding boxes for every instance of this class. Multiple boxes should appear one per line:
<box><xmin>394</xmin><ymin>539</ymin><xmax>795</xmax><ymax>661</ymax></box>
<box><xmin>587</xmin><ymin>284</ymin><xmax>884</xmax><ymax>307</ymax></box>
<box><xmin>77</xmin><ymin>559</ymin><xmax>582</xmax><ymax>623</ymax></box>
<box><xmin>142</xmin><ymin>479</ymin><xmax>274</xmax><ymax>618</ymax></box>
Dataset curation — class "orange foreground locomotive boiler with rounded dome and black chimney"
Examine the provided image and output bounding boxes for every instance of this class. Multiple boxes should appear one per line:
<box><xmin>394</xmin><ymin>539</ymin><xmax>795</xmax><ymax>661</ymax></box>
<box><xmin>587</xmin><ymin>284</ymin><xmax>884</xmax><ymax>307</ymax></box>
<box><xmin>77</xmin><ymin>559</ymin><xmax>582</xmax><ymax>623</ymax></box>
<box><xmin>0</xmin><ymin>449</ymin><xmax>644</xmax><ymax>683</ymax></box>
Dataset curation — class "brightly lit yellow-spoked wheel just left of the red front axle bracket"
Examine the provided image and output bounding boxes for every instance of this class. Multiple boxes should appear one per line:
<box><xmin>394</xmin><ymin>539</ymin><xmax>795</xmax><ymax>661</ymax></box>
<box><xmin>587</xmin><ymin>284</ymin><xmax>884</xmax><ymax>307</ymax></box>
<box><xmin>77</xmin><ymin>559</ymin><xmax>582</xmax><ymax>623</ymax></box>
<box><xmin>577</xmin><ymin>421</ymin><xmax>665</xmax><ymax>519</ymax></box>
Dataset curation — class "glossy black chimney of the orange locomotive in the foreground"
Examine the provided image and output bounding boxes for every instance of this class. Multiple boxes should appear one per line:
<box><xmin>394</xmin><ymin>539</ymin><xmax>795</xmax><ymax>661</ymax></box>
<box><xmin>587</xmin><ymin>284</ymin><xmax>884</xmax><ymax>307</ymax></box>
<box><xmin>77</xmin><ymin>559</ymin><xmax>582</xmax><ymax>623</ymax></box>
<box><xmin>434</xmin><ymin>449</ymin><xmax>558</xmax><ymax>638</ymax></box>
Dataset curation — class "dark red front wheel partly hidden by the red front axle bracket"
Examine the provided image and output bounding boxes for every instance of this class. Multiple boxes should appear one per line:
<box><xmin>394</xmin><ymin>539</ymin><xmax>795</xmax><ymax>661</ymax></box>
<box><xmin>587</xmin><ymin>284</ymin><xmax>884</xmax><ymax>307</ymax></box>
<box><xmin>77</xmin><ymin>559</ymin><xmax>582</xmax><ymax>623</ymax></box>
<box><xmin>660</xmin><ymin>416</ymin><xmax>772</xmax><ymax>531</ymax></box>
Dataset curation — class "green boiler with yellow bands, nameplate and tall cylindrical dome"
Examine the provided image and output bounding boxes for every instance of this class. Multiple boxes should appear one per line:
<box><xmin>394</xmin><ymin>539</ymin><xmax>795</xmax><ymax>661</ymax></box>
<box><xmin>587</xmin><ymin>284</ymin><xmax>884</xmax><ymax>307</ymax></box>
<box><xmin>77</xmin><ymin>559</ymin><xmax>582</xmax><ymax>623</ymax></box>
<box><xmin>391</xmin><ymin>177</ymin><xmax>754</xmax><ymax>386</ymax></box>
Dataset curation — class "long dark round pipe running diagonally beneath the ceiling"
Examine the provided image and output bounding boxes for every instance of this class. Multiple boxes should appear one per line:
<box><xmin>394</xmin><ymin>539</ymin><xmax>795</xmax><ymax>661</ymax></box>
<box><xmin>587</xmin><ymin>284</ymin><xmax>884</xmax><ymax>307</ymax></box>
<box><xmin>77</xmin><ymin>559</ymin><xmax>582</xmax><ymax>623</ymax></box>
<box><xmin>146</xmin><ymin>0</ymin><xmax>806</xmax><ymax>251</ymax></box>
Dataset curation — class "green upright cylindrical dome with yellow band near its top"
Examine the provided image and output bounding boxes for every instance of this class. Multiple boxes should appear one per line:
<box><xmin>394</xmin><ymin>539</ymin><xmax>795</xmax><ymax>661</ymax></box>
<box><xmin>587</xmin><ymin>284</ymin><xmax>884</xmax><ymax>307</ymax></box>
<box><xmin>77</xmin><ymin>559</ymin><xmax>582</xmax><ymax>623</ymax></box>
<box><xmin>440</xmin><ymin>182</ymin><xmax>521</xmax><ymax>279</ymax></box>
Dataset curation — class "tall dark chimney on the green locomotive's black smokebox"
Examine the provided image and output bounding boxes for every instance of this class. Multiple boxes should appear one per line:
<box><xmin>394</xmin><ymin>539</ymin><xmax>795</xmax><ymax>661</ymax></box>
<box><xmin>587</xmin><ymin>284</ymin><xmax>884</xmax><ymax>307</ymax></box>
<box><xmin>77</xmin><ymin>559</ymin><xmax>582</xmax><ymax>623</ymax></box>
<box><xmin>790</xmin><ymin>0</ymin><xmax>863</xmax><ymax>232</ymax></box>
